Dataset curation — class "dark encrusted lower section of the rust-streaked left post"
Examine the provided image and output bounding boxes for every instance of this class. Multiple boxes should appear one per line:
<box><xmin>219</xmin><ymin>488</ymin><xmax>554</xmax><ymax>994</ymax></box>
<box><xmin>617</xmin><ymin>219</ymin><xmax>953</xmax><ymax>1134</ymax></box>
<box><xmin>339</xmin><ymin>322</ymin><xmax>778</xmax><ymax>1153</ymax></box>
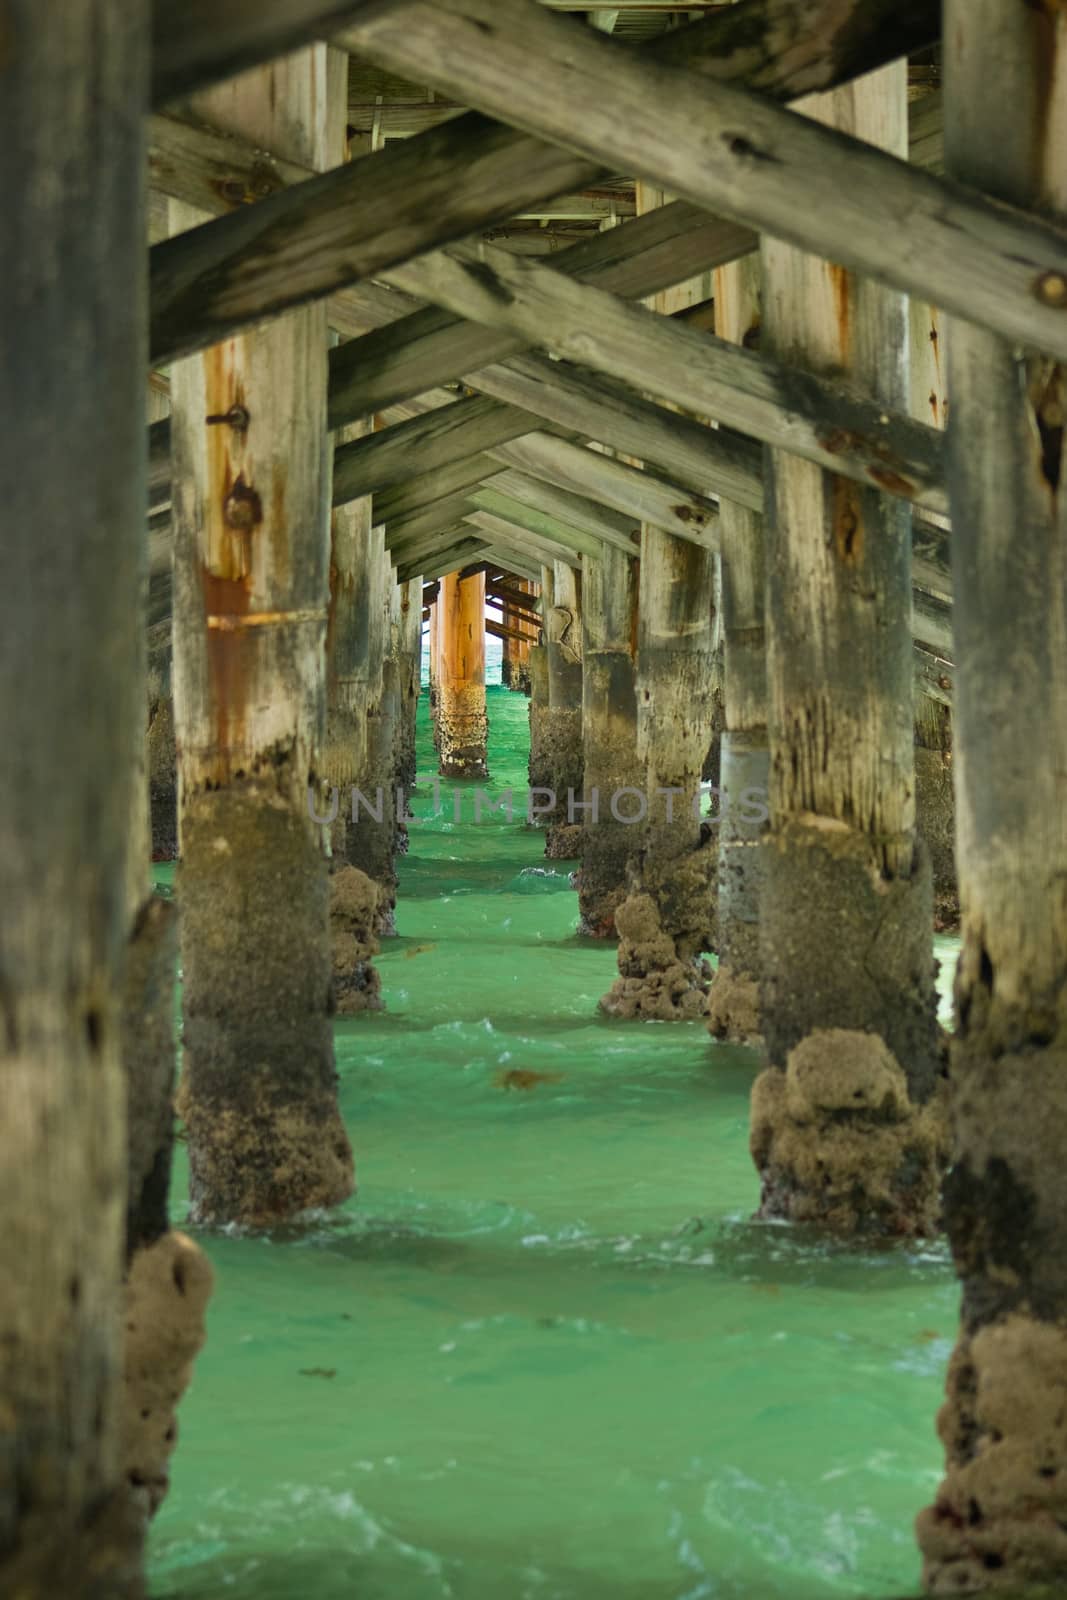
<box><xmin>176</xmin><ymin>781</ymin><xmax>352</xmax><ymax>1227</ymax></box>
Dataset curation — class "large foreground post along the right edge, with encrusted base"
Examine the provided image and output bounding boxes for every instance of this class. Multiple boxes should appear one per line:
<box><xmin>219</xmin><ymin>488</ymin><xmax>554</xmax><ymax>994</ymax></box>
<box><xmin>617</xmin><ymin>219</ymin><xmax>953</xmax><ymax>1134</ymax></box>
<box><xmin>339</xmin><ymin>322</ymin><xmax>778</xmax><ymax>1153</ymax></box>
<box><xmin>918</xmin><ymin>9</ymin><xmax>1067</xmax><ymax>1594</ymax></box>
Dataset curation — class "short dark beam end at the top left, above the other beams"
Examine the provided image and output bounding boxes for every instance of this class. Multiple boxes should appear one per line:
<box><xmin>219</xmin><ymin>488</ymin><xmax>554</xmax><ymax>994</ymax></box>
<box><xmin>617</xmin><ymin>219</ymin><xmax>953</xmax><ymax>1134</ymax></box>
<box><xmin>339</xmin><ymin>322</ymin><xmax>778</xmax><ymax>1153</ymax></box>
<box><xmin>150</xmin><ymin>0</ymin><xmax>366</xmax><ymax>106</ymax></box>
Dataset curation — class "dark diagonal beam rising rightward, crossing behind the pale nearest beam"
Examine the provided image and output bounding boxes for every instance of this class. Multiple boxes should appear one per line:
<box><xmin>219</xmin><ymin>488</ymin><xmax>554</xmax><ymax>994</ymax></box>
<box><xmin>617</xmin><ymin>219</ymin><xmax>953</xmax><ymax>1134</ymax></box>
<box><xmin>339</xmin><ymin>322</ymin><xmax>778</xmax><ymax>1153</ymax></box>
<box><xmin>150</xmin><ymin>0</ymin><xmax>936</xmax><ymax>372</ymax></box>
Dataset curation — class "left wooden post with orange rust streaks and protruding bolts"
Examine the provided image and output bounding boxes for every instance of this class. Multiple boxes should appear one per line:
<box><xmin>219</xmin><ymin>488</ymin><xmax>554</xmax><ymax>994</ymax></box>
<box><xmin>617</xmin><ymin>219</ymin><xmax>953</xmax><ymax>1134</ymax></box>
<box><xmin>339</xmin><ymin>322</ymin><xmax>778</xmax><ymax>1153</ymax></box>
<box><xmin>171</xmin><ymin>46</ymin><xmax>352</xmax><ymax>1224</ymax></box>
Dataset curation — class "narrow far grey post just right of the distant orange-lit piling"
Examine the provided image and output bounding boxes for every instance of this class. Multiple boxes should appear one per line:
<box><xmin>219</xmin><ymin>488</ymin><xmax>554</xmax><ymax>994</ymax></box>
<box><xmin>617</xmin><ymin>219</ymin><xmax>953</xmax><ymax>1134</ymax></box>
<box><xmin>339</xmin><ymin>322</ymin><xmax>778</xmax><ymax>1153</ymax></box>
<box><xmin>541</xmin><ymin>562</ymin><xmax>582</xmax><ymax>861</ymax></box>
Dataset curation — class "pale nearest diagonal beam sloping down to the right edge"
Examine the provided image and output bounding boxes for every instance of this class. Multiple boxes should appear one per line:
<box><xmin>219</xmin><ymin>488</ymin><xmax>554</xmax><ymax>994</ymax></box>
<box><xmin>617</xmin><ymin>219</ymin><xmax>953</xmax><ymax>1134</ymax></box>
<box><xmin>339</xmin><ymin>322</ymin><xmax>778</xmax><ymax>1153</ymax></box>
<box><xmin>337</xmin><ymin>0</ymin><xmax>1067</xmax><ymax>358</ymax></box>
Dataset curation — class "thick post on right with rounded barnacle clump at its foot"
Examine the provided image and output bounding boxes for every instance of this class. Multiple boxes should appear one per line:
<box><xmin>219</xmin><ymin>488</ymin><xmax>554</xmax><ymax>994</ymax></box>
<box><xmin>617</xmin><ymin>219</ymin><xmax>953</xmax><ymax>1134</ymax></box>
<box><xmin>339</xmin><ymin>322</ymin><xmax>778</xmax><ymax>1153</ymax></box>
<box><xmin>752</xmin><ymin>62</ymin><xmax>942</xmax><ymax>1234</ymax></box>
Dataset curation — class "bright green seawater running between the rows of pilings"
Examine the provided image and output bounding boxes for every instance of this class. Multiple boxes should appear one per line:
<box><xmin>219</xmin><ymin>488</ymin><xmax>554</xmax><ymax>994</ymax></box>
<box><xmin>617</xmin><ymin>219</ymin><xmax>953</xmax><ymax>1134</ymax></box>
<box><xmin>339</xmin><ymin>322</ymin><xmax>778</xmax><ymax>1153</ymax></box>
<box><xmin>150</xmin><ymin>690</ymin><xmax>957</xmax><ymax>1600</ymax></box>
